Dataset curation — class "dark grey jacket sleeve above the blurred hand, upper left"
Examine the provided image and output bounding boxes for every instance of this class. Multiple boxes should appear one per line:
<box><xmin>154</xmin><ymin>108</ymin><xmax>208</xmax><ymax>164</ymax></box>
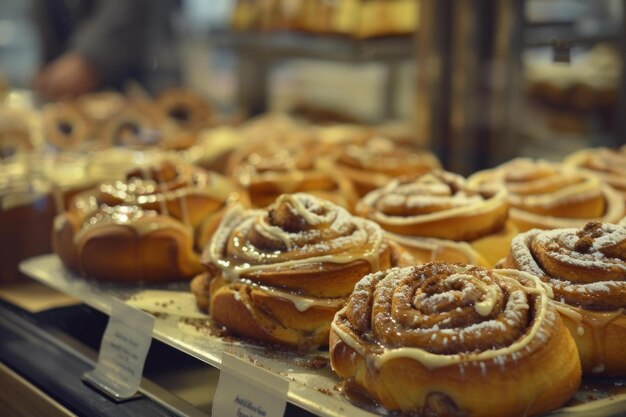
<box><xmin>71</xmin><ymin>0</ymin><xmax>153</xmax><ymax>85</ymax></box>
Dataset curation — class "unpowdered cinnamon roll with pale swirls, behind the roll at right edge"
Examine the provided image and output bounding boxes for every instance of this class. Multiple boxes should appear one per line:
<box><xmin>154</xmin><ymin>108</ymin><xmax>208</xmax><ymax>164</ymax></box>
<box><xmin>469</xmin><ymin>159</ymin><xmax>624</xmax><ymax>231</ymax></box>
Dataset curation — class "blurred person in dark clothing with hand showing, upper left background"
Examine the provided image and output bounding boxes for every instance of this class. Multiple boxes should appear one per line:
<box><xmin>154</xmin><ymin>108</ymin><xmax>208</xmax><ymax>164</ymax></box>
<box><xmin>34</xmin><ymin>0</ymin><xmax>180</xmax><ymax>99</ymax></box>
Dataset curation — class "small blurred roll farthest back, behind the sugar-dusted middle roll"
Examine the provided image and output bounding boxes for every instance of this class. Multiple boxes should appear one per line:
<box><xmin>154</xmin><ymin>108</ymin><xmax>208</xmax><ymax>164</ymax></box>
<box><xmin>335</xmin><ymin>137</ymin><xmax>441</xmax><ymax>196</ymax></box>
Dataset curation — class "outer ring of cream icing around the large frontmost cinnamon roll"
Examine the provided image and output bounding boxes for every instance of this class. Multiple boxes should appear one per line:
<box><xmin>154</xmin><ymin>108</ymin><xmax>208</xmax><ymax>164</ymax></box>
<box><xmin>331</xmin><ymin>266</ymin><xmax>555</xmax><ymax>370</ymax></box>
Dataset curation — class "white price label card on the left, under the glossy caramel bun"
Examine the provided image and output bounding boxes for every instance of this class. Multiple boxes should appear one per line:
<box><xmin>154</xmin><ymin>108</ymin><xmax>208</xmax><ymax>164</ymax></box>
<box><xmin>83</xmin><ymin>300</ymin><xmax>154</xmax><ymax>401</ymax></box>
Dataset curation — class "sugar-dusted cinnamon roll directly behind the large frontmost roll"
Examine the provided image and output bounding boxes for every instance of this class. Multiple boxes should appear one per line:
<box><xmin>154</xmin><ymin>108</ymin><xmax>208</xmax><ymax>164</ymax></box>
<box><xmin>357</xmin><ymin>170</ymin><xmax>516</xmax><ymax>266</ymax></box>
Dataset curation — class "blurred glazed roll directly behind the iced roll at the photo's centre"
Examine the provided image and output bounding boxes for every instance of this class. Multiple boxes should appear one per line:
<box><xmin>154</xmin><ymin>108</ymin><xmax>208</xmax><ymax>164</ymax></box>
<box><xmin>228</xmin><ymin>138</ymin><xmax>357</xmax><ymax>210</ymax></box>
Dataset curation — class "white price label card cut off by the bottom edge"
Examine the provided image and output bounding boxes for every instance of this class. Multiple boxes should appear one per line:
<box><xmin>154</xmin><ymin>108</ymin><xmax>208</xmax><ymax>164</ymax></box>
<box><xmin>212</xmin><ymin>353</ymin><xmax>289</xmax><ymax>417</ymax></box>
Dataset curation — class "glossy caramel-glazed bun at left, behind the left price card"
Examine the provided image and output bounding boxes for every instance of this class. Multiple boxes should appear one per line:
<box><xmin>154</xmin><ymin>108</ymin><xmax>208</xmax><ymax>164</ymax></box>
<box><xmin>53</xmin><ymin>161</ymin><xmax>245</xmax><ymax>281</ymax></box>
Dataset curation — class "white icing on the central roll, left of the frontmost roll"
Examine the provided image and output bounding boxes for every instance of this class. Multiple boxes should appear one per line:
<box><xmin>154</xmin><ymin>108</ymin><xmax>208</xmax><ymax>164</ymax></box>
<box><xmin>205</xmin><ymin>194</ymin><xmax>384</xmax><ymax>308</ymax></box>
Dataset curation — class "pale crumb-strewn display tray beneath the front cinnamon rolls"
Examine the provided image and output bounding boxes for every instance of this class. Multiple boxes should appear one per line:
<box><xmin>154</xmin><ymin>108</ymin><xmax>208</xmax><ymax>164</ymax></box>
<box><xmin>20</xmin><ymin>255</ymin><xmax>626</xmax><ymax>417</ymax></box>
